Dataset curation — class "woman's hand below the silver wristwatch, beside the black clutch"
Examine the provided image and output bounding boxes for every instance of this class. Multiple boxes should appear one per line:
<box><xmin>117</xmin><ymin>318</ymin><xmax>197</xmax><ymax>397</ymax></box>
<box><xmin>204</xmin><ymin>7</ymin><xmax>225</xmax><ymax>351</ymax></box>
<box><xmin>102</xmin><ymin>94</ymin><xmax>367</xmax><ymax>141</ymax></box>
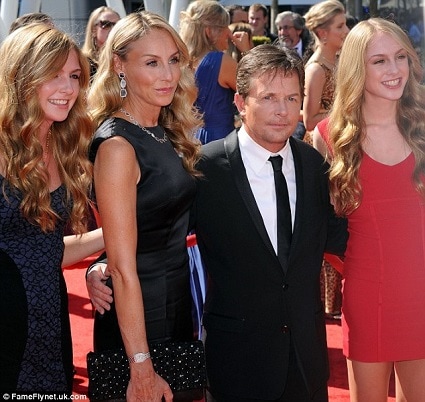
<box><xmin>126</xmin><ymin>360</ymin><xmax>173</xmax><ymax>402</ymax></box>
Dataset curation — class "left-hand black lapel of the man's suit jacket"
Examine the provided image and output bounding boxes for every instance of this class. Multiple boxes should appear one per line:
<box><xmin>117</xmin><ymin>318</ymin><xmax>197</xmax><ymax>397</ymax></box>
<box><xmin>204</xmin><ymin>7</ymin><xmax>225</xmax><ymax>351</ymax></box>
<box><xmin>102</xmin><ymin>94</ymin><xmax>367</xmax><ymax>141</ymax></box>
<box><xmin>224</xmin><ymin>130</ymin><xmax>277</xmax><ymax>260</ymax></box>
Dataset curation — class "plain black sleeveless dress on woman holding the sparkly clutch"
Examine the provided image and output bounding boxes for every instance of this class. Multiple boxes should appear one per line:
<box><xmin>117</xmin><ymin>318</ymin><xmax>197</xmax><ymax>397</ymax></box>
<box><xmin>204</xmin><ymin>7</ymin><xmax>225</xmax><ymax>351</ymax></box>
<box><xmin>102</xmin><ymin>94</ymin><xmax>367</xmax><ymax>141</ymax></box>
<box><xmin>90</xmin><ymin>118</ymin><xmax>196</xmax><ymax>351</ymax></box>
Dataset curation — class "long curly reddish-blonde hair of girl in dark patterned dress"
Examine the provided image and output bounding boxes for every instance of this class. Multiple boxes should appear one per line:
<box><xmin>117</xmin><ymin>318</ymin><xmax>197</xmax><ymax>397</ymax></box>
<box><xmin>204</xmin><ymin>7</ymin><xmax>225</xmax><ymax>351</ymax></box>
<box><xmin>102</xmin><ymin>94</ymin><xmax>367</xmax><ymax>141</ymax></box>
<box><xmin>0</xmin><ymin>24</ymin><xmax>93</xmax><ymax>233</ymax></box>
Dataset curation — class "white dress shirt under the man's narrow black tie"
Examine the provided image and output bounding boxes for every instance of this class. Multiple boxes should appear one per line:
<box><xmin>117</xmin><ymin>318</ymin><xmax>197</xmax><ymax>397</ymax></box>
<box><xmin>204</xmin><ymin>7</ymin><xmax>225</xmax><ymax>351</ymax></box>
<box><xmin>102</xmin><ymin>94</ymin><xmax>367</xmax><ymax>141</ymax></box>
<box><xmin>238</xmin><ymin>126</ymin><xmax>297</xmax><ymax>254</ymax></box>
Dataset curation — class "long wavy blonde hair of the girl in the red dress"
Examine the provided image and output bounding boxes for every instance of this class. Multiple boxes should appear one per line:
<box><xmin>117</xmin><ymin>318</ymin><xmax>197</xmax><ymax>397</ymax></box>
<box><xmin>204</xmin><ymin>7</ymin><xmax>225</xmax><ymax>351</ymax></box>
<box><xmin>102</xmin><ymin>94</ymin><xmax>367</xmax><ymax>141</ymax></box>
<box><xmin>329</xmin><ymin>18</ymin><xmax>425</xmax><ymax>215</ymax></box>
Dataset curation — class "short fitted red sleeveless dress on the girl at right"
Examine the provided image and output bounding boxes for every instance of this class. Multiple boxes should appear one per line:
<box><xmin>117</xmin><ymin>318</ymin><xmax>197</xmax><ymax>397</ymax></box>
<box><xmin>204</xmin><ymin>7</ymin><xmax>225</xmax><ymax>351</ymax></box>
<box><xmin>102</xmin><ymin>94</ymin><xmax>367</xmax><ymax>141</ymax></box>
<box><xmin>342</xmin><ymin>153</ymin><xmax>425</xmax><ymax>362</ymax></box>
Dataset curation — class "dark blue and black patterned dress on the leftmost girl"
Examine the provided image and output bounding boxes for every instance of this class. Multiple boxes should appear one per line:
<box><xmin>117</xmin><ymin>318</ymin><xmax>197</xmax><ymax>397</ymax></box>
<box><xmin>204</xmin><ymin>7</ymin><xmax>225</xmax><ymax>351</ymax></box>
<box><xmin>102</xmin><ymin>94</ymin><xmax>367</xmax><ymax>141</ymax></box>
<box><xmin>0</xmin><ymin>176</ymin><xmax>73</xmax><ymax>394</ymax></box>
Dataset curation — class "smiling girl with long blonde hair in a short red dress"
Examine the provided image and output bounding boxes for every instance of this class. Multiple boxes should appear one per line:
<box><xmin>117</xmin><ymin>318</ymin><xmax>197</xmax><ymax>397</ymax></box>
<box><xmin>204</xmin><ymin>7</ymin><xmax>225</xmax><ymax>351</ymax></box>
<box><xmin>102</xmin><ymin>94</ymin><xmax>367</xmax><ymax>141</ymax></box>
<box><xmin>328</xmin><ymin>18</ymin><xmax>425</xmax><ymax>402</ymax></box>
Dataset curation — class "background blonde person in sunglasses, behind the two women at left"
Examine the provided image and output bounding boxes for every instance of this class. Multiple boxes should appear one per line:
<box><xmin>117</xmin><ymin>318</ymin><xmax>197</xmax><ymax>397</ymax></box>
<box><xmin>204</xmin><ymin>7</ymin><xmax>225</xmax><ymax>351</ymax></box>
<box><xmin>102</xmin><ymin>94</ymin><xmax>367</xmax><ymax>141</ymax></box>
<box><xmin>81</xmin><ymin>6</ymin><xmax>121</xmax><ymax>77</ymax></box>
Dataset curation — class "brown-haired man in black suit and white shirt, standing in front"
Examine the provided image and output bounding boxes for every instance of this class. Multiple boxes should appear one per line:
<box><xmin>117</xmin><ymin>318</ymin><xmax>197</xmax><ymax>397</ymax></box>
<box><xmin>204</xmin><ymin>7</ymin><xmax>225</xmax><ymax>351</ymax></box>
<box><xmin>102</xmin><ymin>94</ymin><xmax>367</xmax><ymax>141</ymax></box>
<box><xmin>193</xmin><ymin>45</ymin><xmax>347</xmax><ymax>402</ymax></box>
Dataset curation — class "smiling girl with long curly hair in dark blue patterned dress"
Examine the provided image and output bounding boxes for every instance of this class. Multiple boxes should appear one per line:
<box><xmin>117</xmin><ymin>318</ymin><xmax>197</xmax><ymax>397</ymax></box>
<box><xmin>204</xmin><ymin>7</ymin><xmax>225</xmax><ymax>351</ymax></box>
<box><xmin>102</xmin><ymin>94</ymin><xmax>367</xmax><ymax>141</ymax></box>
<box><xmin>0</xmin><ymin>24</ymin><xmax>103</xmax><ymax>394</ymax></box>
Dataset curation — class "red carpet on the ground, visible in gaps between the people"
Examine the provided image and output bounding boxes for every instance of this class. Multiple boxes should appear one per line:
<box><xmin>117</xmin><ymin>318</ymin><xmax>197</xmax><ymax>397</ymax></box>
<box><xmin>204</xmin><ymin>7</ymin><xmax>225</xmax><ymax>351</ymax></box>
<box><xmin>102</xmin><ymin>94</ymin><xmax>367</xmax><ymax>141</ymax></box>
<box><xmin>64</xmin><ymin>259</ymin><xmax>395</xmax><ymax>402</ymax></box>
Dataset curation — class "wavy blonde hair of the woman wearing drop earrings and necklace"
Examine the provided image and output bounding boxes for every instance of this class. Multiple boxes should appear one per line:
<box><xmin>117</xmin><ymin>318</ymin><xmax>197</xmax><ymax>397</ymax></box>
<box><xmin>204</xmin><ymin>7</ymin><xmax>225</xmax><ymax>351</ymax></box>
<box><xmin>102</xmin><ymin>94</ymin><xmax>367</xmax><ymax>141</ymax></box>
<box><xmin>88</xmin><ymin>11</ymin><xmax>202</xmax><ymax>175</ymax></box>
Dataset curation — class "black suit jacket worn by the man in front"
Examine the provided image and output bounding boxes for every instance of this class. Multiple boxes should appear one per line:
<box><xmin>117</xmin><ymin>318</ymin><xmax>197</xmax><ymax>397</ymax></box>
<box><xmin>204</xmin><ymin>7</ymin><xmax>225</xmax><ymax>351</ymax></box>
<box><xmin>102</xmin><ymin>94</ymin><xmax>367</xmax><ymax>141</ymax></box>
<box><xmin>193</xmin><ymin>132</ymin><xmax>346</xmax><ymax>399</ymax></box>
